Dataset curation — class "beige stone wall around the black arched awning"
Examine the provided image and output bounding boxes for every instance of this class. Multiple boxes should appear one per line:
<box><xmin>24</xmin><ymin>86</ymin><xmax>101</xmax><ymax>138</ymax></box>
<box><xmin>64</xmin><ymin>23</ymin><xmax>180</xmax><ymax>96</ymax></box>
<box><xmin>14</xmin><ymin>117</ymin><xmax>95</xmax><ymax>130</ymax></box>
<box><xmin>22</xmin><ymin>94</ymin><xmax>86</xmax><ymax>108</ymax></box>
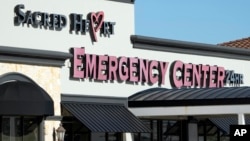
<box><xmin>0</xmin><ymin>63</ymin><xmax>61</xmax><ymax>141</ymax></box>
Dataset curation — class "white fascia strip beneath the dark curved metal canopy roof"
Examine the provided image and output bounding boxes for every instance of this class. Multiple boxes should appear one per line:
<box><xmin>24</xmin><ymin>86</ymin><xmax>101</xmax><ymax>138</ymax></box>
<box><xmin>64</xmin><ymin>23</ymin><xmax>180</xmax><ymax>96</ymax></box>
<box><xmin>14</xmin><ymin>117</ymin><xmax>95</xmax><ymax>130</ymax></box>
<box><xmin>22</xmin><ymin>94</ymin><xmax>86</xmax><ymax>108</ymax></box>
<box><xmin>129</xmin><ymin>104</ymin><xmax>250</xmax><ymax>118</ymax></box>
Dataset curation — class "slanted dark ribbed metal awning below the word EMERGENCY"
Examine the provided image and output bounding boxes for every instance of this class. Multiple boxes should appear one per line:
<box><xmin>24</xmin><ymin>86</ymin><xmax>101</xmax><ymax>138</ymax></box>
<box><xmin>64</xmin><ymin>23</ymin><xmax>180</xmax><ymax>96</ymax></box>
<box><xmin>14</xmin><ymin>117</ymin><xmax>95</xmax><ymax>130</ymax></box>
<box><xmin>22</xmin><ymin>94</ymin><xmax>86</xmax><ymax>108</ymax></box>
<box><xmin>62</xmin><ymin>102</ymin><xmax>150</xmax><ymax>132</ymax></box>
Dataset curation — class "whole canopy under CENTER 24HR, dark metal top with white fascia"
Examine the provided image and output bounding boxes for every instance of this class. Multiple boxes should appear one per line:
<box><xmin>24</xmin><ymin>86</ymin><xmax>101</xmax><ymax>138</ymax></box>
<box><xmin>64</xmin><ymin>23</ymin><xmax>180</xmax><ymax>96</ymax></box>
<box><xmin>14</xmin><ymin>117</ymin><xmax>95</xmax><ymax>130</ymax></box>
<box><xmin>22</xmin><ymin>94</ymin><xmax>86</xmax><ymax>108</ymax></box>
<box><xmin>128</xmin><ymin>87</ymin><xmax>250</xmax><ymax>118</ymax></box>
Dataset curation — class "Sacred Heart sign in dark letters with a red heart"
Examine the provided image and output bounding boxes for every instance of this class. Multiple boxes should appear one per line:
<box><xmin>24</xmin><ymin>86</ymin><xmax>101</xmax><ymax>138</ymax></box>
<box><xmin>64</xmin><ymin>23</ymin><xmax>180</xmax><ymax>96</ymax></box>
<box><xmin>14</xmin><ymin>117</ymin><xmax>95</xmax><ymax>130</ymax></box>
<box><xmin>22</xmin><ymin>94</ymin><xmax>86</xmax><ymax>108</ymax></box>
<box><xmin>14</xmin><ymin>4</ymin><xmax>115</xmax><ymax>42</ymax></box>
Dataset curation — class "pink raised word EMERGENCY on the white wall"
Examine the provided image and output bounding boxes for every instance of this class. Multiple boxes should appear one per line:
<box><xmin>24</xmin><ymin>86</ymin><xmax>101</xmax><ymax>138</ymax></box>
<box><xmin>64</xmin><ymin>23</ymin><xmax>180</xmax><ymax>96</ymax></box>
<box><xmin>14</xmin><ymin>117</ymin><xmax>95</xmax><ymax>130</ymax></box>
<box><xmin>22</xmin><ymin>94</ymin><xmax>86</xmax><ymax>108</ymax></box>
<box><xmin>72</xmin><ymin>48</ymin><xmax>169</xmax><ymax>85</ymax></box>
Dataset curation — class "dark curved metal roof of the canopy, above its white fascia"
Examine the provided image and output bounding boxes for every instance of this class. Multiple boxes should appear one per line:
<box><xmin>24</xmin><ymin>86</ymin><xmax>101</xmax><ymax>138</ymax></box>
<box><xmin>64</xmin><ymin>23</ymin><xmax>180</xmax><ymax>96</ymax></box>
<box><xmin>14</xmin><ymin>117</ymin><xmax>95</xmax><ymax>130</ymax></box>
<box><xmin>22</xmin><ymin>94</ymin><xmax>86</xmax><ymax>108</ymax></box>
<box><xmin>129</xmin><ymin>87</ymin><xmax>250</xmax><ymax>107</ymax></box>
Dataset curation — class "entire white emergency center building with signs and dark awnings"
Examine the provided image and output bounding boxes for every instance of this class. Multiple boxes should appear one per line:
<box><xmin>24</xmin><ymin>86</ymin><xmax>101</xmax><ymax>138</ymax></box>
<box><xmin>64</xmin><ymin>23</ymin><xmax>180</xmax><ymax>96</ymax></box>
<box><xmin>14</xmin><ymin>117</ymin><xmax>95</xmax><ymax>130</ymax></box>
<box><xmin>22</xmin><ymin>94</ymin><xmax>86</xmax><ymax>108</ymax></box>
<box><xmin>0</xmin><ymin>0</ymin><xmax>250</xmax><ymax>141</ymax></box>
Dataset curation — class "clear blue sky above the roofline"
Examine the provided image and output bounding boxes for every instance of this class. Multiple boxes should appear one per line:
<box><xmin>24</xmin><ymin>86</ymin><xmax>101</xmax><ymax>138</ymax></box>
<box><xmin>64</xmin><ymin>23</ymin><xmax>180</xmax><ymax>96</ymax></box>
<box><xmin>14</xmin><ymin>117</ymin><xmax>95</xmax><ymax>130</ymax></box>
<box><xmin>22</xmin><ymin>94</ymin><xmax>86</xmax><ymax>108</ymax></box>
<box><xmin>135</xmin><ymin>0</ymin><xmax>250</xmax><ymax>44</ymax></box>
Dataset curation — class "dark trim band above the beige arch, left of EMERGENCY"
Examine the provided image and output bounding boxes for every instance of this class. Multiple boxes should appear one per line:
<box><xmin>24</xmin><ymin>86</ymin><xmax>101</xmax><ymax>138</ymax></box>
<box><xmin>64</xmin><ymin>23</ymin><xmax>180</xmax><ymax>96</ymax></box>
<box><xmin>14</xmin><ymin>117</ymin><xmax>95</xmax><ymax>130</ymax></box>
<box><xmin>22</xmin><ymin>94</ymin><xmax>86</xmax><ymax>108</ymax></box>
<box><xmin>0</xmin><ymin>46</ymin><xmax>72</xmax><ymax>67</ymax></box>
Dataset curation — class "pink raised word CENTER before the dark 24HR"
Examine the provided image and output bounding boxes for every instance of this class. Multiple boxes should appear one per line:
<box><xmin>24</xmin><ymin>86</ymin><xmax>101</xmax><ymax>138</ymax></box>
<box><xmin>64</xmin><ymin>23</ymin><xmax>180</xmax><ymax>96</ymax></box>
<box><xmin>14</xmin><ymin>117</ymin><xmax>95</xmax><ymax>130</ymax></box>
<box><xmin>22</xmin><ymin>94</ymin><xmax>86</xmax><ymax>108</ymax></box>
<box><xmin>170</xmin><ymin>61</ymin><xmax>225</xmax><ymax>88</ymax></box>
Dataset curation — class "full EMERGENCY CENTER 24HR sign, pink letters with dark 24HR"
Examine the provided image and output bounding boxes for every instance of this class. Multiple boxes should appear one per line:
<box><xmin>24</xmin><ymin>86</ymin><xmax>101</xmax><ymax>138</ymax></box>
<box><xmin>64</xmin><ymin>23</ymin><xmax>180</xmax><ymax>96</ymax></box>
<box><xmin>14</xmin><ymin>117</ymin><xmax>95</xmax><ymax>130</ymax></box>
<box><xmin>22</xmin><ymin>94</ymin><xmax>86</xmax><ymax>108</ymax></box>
<box><xmin>71</xmin><ymin>48</ymin><xmax>243</xmax><ymax>88</ymax></box>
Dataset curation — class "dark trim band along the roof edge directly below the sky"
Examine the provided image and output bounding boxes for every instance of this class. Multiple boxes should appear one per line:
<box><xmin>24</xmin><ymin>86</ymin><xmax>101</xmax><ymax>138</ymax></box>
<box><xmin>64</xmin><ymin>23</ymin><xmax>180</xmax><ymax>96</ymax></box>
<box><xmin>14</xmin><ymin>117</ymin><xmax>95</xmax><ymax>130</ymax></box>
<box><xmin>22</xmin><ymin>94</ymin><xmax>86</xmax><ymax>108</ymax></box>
<box><xmin>130</xmin><ymin>35</ymin><xmax>250</xmax><ymax>60</ymax></box>
